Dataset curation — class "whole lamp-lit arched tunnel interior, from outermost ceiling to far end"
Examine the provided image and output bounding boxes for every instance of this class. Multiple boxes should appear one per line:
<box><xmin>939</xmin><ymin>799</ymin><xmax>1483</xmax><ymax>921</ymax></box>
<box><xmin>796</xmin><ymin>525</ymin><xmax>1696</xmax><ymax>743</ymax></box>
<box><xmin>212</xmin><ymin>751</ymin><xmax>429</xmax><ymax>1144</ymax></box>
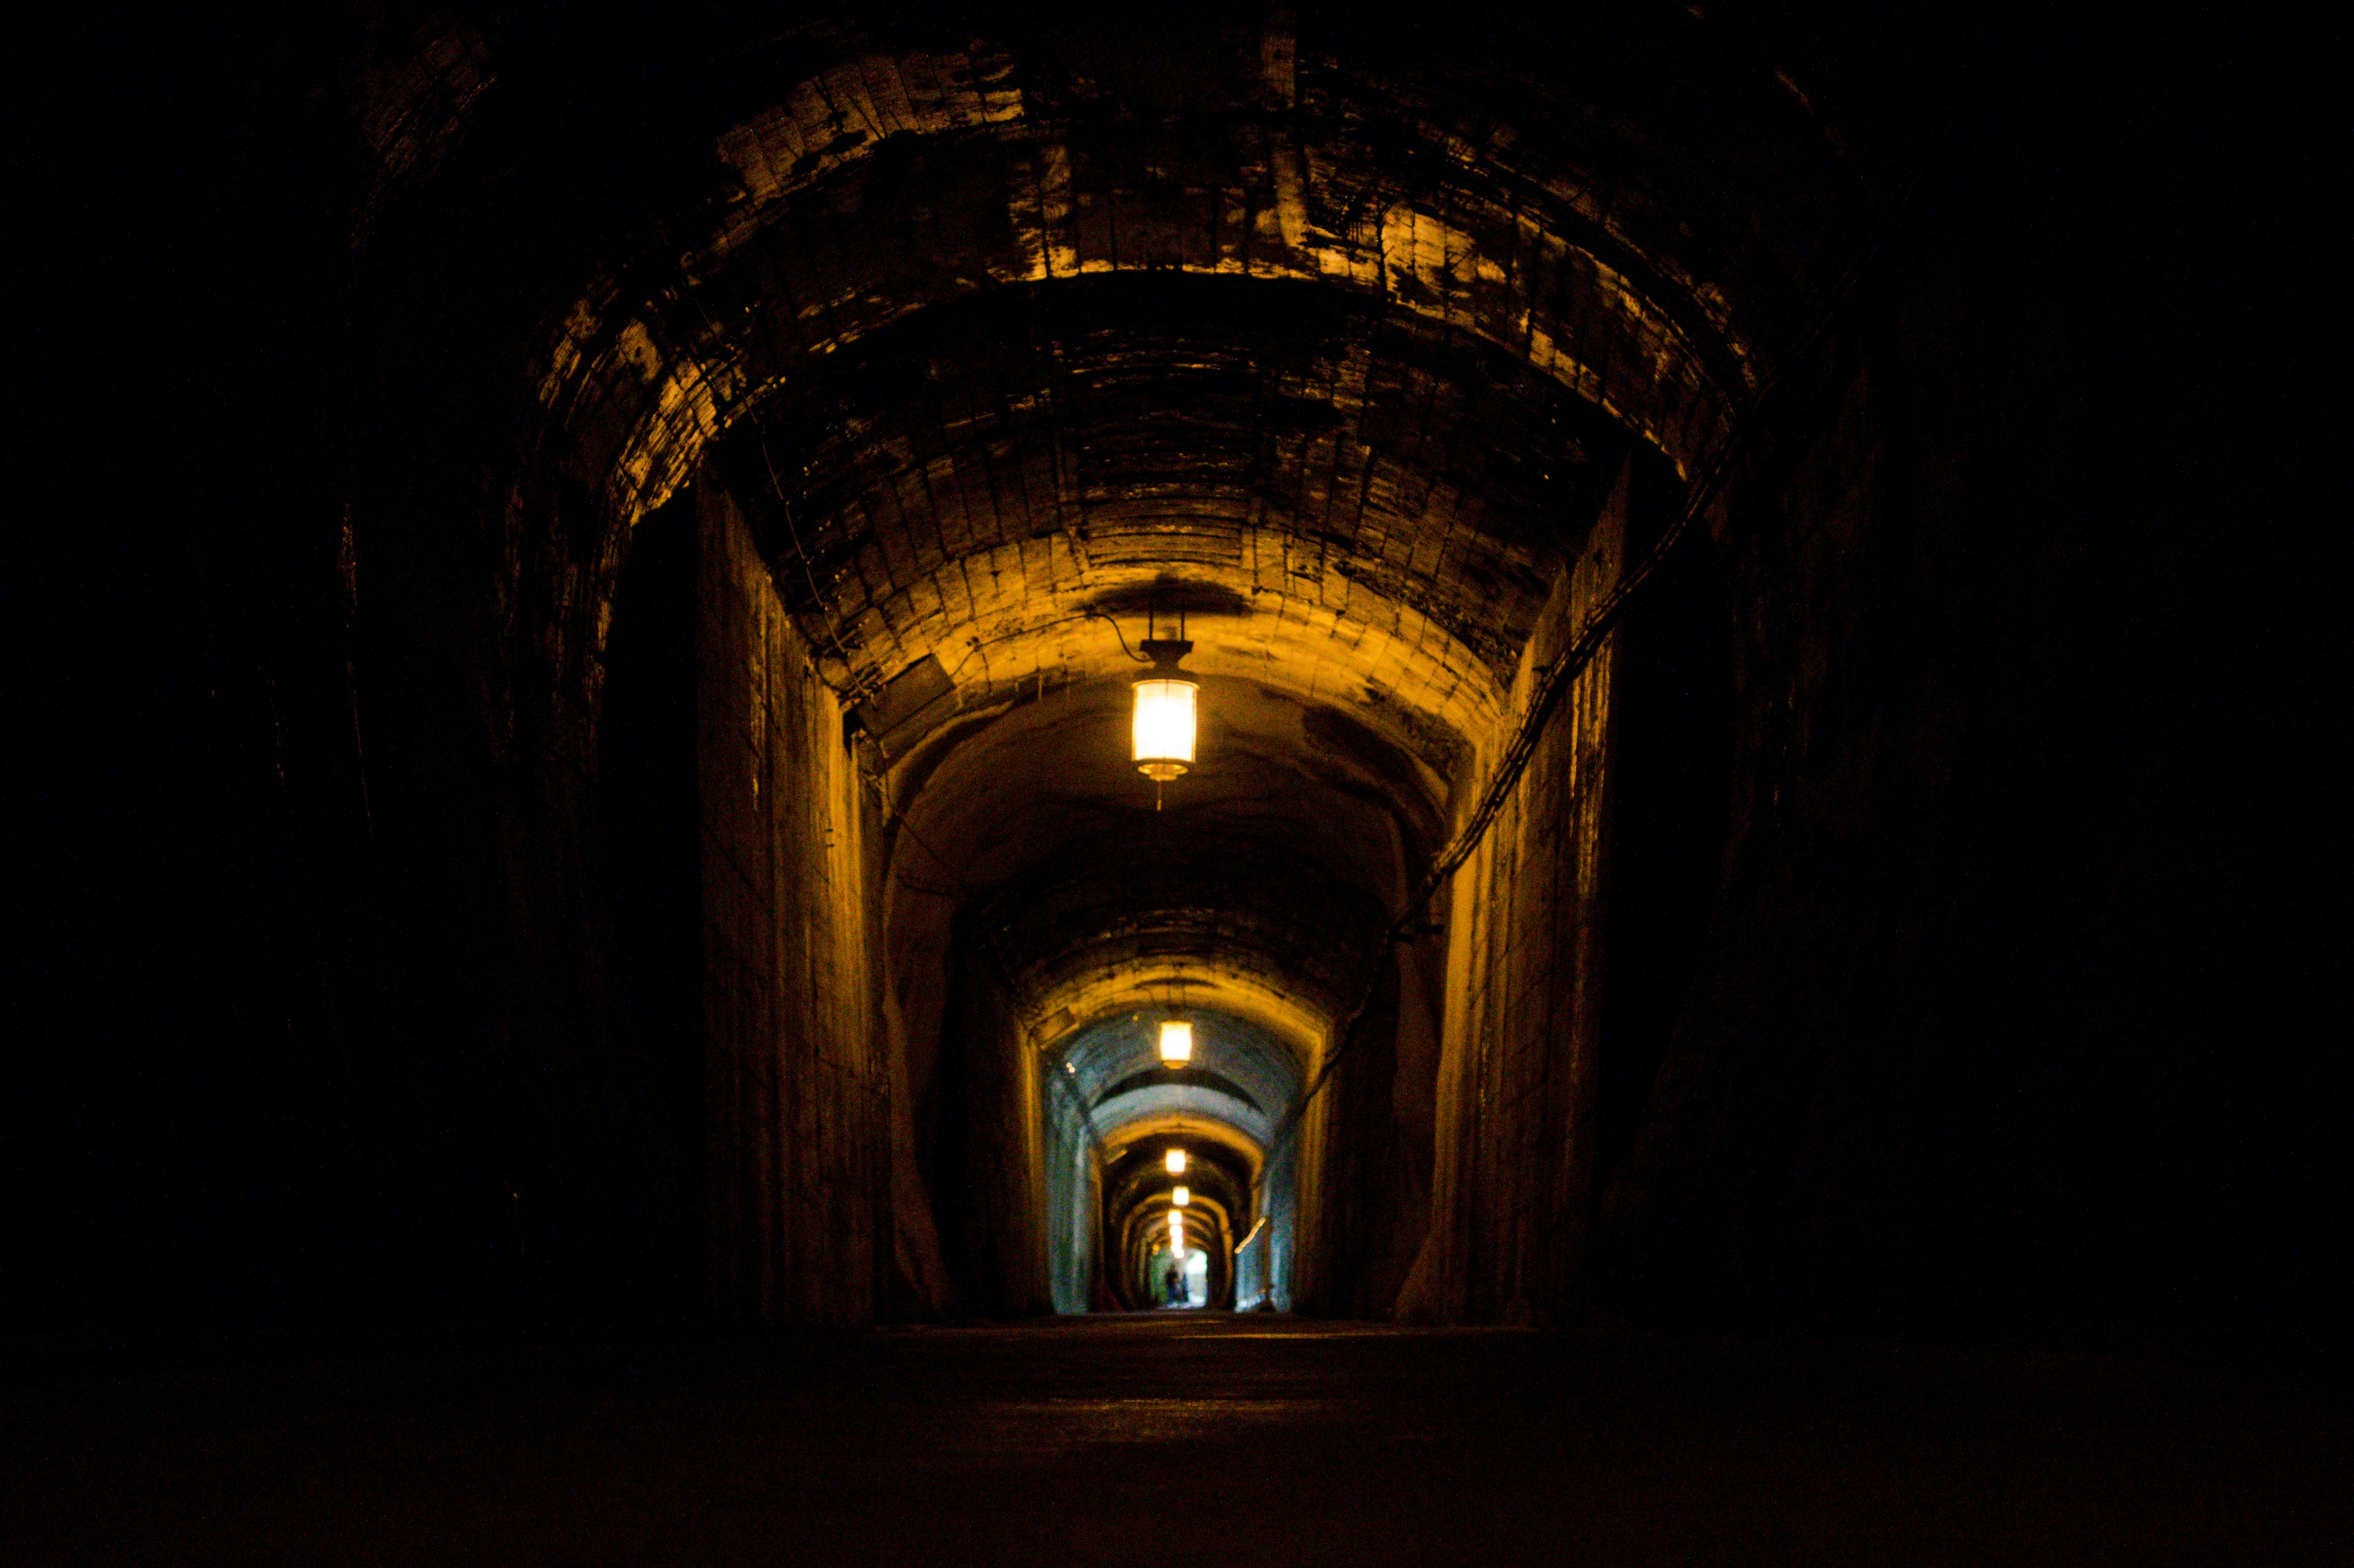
<box><xmin>550</xmin><ymin>14</ymin><xmax>1770</xmax><ymax>1321</ymax></box>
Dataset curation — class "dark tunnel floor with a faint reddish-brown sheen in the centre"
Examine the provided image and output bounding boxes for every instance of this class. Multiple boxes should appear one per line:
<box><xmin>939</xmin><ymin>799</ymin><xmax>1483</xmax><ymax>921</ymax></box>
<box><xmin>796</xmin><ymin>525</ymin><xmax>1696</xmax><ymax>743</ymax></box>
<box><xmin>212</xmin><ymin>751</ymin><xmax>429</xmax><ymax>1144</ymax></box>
<box><xmin>0</xmin><ymin>1314</ymin><xmax>2354</xmax><ymax>1568</ymax></box>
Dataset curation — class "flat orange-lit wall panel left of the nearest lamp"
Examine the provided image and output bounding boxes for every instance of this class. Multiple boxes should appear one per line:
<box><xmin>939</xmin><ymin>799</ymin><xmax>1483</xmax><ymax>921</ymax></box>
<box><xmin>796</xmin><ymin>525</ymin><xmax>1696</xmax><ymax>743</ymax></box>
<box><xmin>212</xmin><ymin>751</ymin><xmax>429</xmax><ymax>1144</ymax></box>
<box><xmin>697</xmin><ymin>487</ymin><xmax>890</xmax><ymax>1323</ymax></box>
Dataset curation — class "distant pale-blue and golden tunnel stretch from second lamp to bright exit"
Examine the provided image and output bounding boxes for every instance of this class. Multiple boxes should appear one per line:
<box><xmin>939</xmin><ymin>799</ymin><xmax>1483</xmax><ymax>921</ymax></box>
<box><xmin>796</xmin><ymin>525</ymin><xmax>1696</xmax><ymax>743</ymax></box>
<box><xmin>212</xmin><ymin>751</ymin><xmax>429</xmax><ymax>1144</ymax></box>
<box><xmin>1040</xmin><ymin>1008</ymin><xmax>1304</xmax><ymax>1311</ymax></box>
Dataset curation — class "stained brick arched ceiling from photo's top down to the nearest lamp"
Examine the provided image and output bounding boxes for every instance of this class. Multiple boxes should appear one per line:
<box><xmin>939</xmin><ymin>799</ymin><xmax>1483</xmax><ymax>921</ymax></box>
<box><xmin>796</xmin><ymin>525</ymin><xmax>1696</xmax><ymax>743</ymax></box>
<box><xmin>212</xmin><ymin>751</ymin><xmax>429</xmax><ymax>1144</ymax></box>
<box><xmin>535</xmin><ymin>7</ymin><xmax>1862</xmax><ymax>756</ymax></box>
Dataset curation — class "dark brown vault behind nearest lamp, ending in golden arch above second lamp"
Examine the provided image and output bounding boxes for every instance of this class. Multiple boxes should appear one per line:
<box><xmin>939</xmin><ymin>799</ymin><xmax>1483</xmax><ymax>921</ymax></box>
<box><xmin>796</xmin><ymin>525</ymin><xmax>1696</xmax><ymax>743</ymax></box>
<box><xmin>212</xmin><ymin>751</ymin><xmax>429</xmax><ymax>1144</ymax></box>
<box><xmin>890</xmin><ymin>659</ymin><xmax>1446</xmax><ymax>1052</ymax></box>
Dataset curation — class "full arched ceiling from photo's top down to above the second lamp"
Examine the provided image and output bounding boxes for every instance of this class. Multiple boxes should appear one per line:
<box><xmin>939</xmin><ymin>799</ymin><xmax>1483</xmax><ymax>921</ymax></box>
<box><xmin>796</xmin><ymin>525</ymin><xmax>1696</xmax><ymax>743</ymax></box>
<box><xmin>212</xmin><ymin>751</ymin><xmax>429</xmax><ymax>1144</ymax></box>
<box><xmin>444</xmin><ymin>7</ymin><xmax>1872</xmax><ymax>1172</ymax></box>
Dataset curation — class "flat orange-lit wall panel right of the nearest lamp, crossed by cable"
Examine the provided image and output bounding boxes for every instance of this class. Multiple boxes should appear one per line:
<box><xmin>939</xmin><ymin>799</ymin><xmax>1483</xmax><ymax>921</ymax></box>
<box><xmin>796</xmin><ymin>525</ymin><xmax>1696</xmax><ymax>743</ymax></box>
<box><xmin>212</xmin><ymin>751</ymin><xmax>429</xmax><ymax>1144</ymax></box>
<box><xmin>1401</xmin><ymin>471</ymin><xmax>1629</xmax><ymax>1323</ymax></box>
